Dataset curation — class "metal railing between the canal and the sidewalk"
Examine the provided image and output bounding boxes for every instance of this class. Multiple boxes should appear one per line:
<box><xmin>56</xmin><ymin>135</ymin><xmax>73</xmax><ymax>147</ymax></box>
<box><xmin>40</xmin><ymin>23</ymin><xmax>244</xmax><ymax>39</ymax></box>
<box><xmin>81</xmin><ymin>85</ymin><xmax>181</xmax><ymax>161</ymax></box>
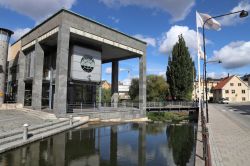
<box><xmin>201</xmin><ymin>104</ymin><xmax>212</xmax><ymax>166</ymax></box>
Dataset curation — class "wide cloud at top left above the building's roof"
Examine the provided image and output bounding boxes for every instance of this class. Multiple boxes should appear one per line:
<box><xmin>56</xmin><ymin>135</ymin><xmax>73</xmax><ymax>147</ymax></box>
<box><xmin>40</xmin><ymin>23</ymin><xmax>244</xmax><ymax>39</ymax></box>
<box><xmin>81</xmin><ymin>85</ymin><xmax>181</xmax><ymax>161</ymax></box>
<box><xmin>0</xmin><ymin>0</ymin><xmax>76</xmax><ymax>22</ymax></box>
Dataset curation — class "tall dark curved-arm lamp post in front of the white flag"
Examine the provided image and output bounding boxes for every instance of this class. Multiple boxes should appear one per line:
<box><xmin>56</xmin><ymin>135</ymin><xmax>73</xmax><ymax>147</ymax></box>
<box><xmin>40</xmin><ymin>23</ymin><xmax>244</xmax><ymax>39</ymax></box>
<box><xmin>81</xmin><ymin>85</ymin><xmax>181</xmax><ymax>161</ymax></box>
<box><xmin>202</xmin><ymin>10</ymin><xmax>248</xmax><ymax>123</ymax></box>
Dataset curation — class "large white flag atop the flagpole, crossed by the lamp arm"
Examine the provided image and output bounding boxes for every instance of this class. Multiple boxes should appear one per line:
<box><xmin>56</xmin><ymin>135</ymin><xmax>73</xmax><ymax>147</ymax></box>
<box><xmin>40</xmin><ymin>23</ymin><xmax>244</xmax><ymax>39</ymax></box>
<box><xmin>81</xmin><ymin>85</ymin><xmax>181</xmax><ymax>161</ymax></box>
<box><xmin>196</xmin><ymin>12</ymin><xmax>221</xmax><ymax>31</ymax></box>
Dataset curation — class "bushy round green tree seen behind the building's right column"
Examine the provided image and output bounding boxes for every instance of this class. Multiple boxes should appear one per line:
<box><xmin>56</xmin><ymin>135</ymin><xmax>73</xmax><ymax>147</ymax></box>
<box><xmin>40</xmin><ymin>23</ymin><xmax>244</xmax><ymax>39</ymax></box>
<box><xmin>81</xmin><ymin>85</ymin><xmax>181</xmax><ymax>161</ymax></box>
<box><xmin>129</xmin><ymin>75</ymin><xmax>168</xmax><ymax>101</ymax></box>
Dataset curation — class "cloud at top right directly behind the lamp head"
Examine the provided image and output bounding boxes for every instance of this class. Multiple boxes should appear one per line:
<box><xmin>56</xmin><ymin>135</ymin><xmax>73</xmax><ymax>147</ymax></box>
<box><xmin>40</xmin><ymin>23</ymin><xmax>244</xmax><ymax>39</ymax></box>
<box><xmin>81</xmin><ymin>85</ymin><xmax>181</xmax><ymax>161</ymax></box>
<box><xmin>218</xmin><ymin>0</ymin><xmax>250</xmax><ymax>26</ymax></box>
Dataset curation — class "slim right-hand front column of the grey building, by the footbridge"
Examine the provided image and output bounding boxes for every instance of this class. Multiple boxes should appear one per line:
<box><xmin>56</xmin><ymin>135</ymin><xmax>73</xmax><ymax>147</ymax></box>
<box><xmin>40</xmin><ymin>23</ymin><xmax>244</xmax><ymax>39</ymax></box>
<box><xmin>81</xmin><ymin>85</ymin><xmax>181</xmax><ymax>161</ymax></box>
<box><xmin>139</xmin><ymin>52</ymin><xmax>147</xmax><ymax>115</ymax></box>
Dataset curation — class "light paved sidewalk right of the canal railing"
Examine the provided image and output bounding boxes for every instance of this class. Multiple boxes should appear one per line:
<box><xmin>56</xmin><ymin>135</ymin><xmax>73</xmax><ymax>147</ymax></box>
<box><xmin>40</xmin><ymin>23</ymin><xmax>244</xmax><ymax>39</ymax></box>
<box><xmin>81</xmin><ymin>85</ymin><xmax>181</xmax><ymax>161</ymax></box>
<box><xmin>208</xmin><ymin>104</ymin><xmax>250</xmax><ymax>166</ymax></box>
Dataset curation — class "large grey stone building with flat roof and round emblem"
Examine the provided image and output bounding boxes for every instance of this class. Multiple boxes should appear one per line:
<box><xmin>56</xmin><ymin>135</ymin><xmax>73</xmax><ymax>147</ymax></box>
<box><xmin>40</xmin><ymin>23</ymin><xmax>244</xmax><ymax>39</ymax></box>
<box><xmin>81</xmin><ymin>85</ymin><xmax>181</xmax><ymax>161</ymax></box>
<box><xmin>8</xmin><ymin>9</ymin><xmax>146</xmax><ymax>114</ymax></box>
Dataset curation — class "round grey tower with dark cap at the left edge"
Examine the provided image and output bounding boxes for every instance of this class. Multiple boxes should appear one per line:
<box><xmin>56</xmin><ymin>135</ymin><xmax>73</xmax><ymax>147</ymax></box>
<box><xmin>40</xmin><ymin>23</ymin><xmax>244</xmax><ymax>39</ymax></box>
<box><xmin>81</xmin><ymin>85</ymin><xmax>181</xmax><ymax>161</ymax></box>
<box><xmin>0</xmin><ymin>28</ymin><xmax>13</xmax><ymax>106</ymax></box>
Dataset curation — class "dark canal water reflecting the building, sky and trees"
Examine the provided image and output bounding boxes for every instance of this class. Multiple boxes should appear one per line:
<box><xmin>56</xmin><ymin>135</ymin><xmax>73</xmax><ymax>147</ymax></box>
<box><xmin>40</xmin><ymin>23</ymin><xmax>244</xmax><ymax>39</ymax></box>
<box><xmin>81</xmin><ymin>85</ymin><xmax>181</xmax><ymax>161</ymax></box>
<box><xmin>0</xmin><ymin>123</ymin><xmax>195</xmax><ymax>166</ymax></box>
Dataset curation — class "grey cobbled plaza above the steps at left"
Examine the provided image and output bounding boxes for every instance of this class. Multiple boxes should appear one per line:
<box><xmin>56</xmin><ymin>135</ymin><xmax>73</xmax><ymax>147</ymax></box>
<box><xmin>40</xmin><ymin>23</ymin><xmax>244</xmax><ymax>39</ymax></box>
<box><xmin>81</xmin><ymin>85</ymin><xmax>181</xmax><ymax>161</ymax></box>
<box><xmin>0</xmin><ymin>110</ymin><xmax>45</xmax><ymax>134</ymax></box>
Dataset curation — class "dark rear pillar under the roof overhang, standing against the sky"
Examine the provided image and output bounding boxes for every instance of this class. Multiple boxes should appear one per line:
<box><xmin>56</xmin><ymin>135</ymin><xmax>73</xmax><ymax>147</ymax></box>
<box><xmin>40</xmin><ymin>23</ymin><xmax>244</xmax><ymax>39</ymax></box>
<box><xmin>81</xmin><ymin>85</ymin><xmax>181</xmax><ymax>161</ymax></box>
<box><xmin>111</xmin><ymin>61</ymin><xmax>119</xmax><ymax>108</ymax></box>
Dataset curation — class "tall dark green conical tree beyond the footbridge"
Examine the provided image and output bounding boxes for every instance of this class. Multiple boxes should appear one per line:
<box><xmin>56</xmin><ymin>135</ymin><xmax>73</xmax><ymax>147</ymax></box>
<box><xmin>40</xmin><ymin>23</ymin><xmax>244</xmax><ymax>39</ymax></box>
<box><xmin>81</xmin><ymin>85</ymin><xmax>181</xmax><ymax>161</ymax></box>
<box><xmin>166</xmin><ymin>35</ymin><xmax>195</xmax><ymax>100</ymax></box>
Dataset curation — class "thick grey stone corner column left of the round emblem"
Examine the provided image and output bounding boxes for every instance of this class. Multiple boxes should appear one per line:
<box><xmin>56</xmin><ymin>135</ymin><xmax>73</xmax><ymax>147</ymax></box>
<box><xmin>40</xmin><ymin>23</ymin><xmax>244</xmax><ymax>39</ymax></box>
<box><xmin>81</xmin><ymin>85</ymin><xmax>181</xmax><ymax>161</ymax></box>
<box><xmin>54</xmin><ymin>24</ymin><xmax>70</xmax><ymax>114</ymax></box>
